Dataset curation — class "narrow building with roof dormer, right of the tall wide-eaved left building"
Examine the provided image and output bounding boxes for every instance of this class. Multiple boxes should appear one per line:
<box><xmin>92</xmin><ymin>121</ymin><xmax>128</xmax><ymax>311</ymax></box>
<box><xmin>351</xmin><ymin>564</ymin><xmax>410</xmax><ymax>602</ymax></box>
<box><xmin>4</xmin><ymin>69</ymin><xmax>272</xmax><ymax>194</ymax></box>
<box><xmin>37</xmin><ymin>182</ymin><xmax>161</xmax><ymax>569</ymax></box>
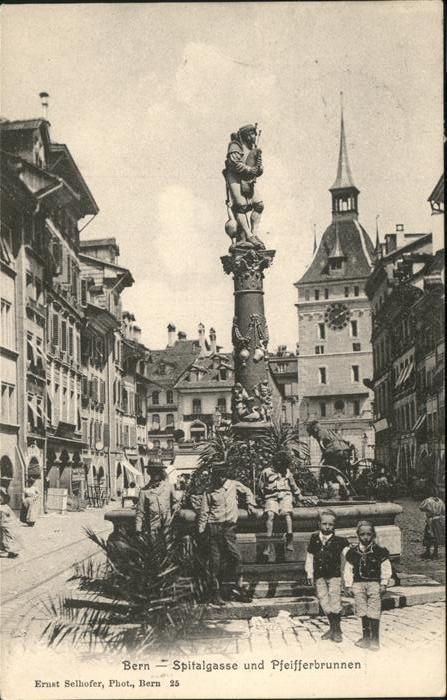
<box><xmin>79</xmin><ymin>238</ymin><xmax>136</xmax><ymax>496</ymax></box>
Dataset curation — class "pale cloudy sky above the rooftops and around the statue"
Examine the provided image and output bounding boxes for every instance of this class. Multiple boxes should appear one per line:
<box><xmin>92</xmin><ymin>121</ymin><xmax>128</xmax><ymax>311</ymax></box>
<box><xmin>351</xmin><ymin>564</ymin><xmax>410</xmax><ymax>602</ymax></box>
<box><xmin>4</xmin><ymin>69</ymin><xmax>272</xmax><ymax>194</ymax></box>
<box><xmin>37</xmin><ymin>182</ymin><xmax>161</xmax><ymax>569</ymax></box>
<box><xmin>1</xmin><ymin>0</ymin><xmax>443</xmax><ymax>351</ymax></box>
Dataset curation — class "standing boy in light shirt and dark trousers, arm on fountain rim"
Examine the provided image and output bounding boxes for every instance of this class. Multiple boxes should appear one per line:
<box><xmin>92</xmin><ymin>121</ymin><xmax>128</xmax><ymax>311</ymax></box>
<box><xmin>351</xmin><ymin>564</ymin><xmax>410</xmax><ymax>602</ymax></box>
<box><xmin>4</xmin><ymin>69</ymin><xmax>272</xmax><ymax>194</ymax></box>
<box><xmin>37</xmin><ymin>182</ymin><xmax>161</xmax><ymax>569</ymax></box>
<box><xmin>197</xmin><ymin>462</ymin><xmax>256</xmax><ymax>605</ymax></box>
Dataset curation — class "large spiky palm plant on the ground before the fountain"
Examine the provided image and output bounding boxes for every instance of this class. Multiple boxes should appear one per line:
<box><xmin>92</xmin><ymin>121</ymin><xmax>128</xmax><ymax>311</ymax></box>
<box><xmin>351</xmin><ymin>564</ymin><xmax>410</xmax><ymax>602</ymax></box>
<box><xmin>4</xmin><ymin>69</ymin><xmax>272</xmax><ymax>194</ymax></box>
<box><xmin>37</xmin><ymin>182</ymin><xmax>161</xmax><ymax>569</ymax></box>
<box><xmin>43</xmin><ymin>529</ymin><xmax>209</xmax><ymax>653</ymax></box>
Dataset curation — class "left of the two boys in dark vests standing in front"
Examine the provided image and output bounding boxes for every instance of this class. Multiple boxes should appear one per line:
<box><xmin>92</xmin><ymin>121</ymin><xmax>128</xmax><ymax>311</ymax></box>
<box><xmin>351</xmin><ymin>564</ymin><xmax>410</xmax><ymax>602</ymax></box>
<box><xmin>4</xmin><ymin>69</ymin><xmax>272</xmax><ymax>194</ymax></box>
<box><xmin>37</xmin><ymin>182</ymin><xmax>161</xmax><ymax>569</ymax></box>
<box><xmin>305</xmin><ymin>510</ymin><xmax>349</xmax><ymax>642</ymax></box>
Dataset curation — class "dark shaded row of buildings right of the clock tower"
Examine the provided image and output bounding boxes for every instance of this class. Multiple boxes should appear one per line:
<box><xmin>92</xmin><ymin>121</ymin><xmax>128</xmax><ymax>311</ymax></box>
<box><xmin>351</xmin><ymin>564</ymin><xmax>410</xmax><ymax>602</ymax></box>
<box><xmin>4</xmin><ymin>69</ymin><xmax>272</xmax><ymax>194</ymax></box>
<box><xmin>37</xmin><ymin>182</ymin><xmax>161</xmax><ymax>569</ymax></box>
<box><xmin>366</xmin><ymin>225</ymin><xmax>444</xmax><ymax>481</ymax></box>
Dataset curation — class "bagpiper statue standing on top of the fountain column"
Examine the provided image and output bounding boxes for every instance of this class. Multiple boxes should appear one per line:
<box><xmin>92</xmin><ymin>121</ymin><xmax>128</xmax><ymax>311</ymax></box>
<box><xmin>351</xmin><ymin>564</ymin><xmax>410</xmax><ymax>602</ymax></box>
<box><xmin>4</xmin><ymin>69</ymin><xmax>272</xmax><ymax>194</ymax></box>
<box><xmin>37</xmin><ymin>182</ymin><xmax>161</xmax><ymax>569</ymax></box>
<box><xmin>223</xmin><ymin>124</ymin><xmax>265</xmax><ymax>248</ymax></box>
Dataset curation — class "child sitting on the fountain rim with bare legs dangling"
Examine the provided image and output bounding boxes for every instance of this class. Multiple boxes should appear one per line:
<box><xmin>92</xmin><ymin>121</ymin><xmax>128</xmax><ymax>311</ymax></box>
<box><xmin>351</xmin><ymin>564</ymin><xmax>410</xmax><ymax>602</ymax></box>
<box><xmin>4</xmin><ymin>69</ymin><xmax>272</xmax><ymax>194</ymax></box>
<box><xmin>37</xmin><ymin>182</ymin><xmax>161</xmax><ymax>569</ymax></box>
<box><xmin>259</xmin><ymin>450</ymin><xmax>303</xmax><ymax>554</ymax></box>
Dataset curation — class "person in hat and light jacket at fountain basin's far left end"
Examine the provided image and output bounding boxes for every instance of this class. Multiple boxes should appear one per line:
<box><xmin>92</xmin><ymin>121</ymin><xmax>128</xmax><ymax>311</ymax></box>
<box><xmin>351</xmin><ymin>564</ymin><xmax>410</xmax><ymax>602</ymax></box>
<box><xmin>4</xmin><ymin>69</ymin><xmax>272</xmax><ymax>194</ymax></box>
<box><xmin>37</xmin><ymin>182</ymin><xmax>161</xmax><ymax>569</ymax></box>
<box><xmin>135</xmin><ymin>460</ymin><xmax>179</xmax><ymax>537</ymax></box>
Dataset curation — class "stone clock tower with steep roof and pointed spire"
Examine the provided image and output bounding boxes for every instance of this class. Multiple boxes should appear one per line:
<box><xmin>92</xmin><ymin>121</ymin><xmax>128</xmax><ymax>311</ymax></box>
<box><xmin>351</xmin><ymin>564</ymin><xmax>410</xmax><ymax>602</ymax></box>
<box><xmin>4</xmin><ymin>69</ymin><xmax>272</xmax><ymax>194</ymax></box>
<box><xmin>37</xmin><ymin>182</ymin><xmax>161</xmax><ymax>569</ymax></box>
<box><xmin>295</xmin><ymin>104</ymin><xmax>374</xmax><ymax>464</ymax></box>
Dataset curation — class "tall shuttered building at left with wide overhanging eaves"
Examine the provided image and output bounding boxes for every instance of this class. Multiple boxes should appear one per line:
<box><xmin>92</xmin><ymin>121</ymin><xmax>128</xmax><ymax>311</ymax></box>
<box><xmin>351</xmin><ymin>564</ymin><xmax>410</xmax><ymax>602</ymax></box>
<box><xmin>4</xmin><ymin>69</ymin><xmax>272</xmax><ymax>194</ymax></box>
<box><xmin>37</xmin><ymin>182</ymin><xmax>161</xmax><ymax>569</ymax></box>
<box><xmin>0</xmin><ymin>119</ymin><xmax>98</xmax><ymax>505</ymax></box>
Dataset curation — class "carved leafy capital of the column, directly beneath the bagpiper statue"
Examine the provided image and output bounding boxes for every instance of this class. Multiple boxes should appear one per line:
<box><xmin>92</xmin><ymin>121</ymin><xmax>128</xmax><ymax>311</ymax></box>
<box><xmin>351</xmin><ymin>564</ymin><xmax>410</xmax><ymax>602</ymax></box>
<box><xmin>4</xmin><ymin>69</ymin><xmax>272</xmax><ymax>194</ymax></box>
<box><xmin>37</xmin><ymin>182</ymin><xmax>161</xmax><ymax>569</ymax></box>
<box><xmin>221</xmin><ymin>249</ymin><xmax>275</xmax><ymax>292</ymax></box>
